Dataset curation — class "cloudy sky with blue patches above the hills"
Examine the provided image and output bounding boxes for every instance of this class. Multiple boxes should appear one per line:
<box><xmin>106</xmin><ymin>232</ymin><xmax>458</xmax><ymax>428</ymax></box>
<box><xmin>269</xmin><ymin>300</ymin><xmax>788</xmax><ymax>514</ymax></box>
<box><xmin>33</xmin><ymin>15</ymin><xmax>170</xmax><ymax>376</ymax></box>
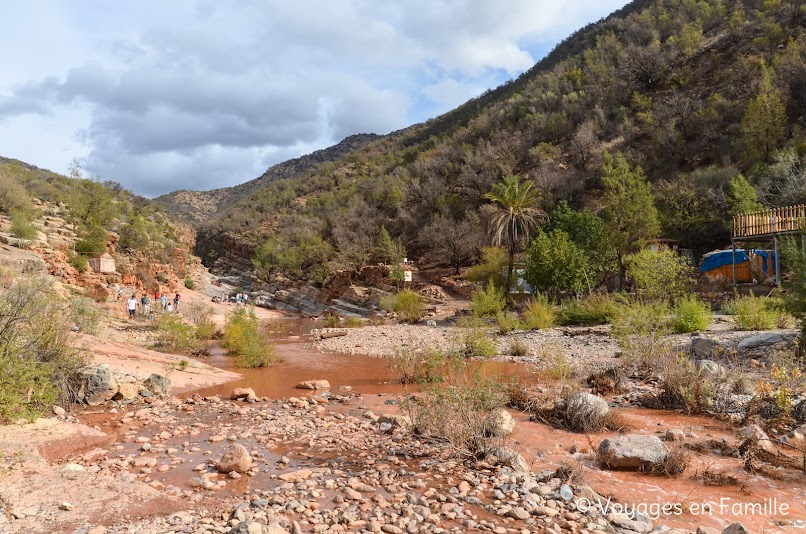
<box><xmin>0</xmin><ymin>0</ymin><xmax>626</xmax><ymax>197</ymax></box>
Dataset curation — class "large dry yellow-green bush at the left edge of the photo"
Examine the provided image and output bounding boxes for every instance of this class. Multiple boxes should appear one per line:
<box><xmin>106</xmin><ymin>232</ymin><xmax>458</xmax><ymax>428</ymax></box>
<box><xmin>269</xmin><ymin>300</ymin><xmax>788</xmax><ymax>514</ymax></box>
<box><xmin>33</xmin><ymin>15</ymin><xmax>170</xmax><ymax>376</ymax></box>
<box><xmin>0</xmin><ymin>280</ymin><xmax>86</xmax><ymax>423</ymax></box>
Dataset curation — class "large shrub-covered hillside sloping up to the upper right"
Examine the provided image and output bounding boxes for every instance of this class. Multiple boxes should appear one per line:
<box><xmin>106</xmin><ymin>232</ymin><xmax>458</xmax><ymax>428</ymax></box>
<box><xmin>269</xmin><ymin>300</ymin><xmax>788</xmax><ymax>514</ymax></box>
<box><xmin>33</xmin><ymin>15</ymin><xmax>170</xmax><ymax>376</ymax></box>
<box><xmin>174</xmin><ymin>0</ymin><xmax>806</xmax><ymax>288</ymax></box>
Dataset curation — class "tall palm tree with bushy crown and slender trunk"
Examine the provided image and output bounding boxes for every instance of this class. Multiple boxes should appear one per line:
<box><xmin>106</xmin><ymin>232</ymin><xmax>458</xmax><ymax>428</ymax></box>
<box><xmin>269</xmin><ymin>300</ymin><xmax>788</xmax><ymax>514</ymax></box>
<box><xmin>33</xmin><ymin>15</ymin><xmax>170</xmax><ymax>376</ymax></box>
<box><xmin>484</xmin><ymin>176</ymin><xmax>548</xmax><ymax>298</ymax></box>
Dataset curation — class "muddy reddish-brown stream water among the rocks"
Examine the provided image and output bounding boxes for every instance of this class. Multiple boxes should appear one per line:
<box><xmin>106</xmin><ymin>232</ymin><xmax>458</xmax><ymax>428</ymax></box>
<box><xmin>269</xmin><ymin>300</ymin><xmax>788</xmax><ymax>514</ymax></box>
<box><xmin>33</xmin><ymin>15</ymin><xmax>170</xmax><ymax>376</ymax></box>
<box><xmin>79</xmin><ymin>320</ymin><xmax>806</xmax><ymax>532</ymax></box>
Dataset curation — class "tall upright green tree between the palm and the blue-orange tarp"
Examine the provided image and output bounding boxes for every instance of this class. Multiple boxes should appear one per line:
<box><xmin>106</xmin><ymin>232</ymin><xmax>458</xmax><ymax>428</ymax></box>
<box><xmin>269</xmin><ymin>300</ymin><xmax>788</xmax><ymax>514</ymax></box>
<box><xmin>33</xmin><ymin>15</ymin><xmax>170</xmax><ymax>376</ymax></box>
<box><xmin>602</xmin><ymin>152</ymin><xmax>660</xmax><ymax>283</ymax></box>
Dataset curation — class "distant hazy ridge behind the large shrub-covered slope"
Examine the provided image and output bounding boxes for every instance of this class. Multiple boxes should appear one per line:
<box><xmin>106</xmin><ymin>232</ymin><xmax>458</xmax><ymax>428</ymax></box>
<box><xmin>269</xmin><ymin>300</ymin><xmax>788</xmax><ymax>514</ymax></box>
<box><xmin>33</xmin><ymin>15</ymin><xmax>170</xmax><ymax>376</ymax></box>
<box><xmin>159</xmin><ymin>134</ymin><xmax>379</xmax><ymax>224</ymax></box>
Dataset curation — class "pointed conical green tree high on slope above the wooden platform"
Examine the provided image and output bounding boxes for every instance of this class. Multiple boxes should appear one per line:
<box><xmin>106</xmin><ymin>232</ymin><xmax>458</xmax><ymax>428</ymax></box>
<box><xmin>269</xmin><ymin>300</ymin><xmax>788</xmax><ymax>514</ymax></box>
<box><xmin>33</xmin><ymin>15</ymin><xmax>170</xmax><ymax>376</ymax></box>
<box><xmin>741</xmin><ymin>67</ymin><xmax>786</xmax><ymax>162</ymax></box>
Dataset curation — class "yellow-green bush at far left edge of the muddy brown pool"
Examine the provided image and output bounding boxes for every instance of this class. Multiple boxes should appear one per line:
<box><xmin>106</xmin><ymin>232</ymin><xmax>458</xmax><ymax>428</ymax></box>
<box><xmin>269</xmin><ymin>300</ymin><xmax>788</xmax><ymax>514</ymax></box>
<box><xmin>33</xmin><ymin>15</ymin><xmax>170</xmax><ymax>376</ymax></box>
<box><xmin>223</xmin><ymin>308</ymin><xmax>277</xmax><ymax>368</ymax></box>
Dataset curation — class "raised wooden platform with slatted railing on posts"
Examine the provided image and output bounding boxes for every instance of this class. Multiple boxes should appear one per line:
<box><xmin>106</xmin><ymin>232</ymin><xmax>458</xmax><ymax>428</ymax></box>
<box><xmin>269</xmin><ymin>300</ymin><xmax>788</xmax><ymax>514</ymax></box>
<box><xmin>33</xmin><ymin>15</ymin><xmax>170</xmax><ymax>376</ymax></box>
<box><xmin>731</xmin><ymin>205</ymin><xmax>806</xmax><ymax>285</ymax></box>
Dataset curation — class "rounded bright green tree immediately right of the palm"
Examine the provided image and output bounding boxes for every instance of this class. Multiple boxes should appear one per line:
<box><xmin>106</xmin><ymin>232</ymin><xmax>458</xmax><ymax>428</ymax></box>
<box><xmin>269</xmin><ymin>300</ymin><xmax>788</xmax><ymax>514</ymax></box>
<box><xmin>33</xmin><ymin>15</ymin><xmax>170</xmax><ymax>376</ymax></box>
<box><xmin>525</xmin><ymin>230</ymin><xmax>591</xmax><ymax>300</ymax></box>
